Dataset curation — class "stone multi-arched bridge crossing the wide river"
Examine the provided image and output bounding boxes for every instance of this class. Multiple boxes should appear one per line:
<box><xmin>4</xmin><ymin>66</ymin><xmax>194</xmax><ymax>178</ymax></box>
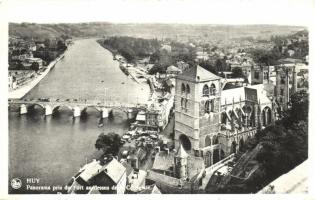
<box><xmin>9</xmin><ymin>98</ymin><xmax>146</xmax><ymax>118</ymax></box>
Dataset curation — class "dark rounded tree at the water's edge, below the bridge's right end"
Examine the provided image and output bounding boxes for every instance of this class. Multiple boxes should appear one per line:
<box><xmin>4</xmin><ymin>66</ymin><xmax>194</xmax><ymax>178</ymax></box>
<box><xmin>95</xmin><ymin>132</ymin><xmax>121</xmax><ymax>155</ymax></box>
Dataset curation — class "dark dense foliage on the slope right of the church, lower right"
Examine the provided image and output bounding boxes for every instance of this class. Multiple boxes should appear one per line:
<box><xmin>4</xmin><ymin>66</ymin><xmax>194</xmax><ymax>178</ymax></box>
<box><xmin>217</xmin><ymin>91</ymin><xmax>309</xmax><ymax>193</ymax></box>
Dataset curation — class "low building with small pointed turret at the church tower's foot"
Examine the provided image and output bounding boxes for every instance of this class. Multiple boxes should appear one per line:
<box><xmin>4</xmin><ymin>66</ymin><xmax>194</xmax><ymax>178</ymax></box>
<box><xmin>146</xmin><ymin>145</ymin><xmax>205</xmax><ymax>194</ymax></box>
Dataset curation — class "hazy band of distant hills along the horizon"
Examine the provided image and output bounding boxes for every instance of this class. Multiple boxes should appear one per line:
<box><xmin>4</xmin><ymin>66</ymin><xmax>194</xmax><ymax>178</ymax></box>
<box><xmin>9</xmin><ymin>22</ymin><xmax>305</xmax><ymax>41</ymax></box>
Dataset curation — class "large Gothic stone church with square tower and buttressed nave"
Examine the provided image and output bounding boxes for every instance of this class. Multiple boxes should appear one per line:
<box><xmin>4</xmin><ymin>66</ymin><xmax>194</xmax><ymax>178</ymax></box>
<box><xmin>175</xmin><ymin>66</ymin><xmax>275</xmax><ymax>167</ymax></box>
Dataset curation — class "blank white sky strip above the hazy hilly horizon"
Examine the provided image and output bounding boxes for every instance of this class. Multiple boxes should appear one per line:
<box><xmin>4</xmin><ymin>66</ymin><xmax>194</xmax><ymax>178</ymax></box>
<box><xmin>0</xmin><ymin>0</ymin><xmax>315</xmax><ymax>25</ymax></box>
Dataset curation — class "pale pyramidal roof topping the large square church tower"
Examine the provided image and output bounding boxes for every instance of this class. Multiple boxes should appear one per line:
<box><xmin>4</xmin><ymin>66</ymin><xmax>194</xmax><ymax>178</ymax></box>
<box><xmin>177</xmin><ymin>65</ymin><xmax>221</xmax><ymax>82</ymax></box>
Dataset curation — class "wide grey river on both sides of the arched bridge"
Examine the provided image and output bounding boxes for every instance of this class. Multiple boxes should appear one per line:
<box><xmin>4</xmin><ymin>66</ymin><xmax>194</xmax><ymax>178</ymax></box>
<box><xmin>9</xmin><ymin>39</ymin><xmax>150</xmax><ymax>193</ymax></box>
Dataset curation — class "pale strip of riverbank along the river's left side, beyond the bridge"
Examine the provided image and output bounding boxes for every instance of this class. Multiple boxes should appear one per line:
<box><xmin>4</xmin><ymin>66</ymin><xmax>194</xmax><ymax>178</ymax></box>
<box><xmin>8</xmin><ymin>51</ymin><xmax>66</xmax><ymax>99</ymax></box>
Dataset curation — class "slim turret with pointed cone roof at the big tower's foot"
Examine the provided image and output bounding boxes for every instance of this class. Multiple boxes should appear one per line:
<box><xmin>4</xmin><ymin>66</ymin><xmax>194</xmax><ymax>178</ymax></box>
<box><xmin>174</xmin><ymin>145</ymin><xmax>188</xmax><ymax>179</ymax></box>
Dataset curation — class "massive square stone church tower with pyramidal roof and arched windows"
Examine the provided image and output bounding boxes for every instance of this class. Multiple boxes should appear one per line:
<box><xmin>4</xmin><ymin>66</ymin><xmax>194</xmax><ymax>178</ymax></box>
<box><xmin>175</xmin><ymin>66</ymin><xmax>221</xmax><ymax>156</ymax></box>
